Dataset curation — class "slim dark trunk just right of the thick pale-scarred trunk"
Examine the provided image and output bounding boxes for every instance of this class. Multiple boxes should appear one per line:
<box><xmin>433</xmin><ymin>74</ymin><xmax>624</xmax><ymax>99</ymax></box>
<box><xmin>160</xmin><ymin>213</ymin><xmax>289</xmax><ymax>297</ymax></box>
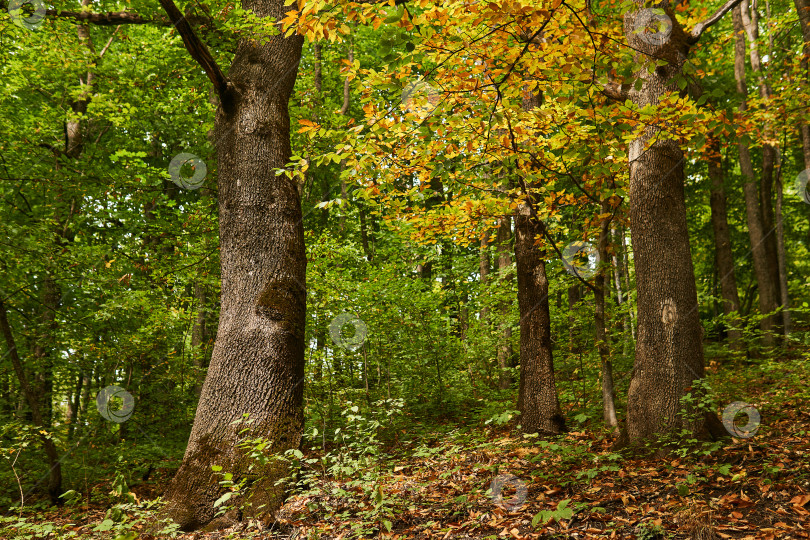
<box><xmin>708</xmin><ymin>135</ymin><xmax>742</xmax><ymax>349</ymax></box>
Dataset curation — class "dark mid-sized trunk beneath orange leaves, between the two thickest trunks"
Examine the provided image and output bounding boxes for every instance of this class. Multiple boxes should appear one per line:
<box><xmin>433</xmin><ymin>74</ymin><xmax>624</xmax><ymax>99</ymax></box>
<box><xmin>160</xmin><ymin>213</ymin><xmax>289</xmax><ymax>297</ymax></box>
<box><xmin>515</xmin><ymin>204</ymin><xmax>565</xmax><ymax>434</ymax></box>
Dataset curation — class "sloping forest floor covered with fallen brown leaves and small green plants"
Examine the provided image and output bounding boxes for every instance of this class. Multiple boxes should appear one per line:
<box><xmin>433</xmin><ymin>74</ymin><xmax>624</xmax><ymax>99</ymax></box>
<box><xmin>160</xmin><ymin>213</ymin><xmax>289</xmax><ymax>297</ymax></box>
<box><xmin>6</xmin><ymin>352</ymin><xmax>810</xmax><ymax>540</ymax></box>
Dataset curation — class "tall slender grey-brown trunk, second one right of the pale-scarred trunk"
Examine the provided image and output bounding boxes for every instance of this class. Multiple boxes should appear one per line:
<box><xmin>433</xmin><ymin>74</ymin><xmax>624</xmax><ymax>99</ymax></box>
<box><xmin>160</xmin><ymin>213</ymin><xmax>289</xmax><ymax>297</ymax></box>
<box><xmin>733</xmin><ymin>6</ymin><xmax>778</xmax><ymax>346</ymax></box>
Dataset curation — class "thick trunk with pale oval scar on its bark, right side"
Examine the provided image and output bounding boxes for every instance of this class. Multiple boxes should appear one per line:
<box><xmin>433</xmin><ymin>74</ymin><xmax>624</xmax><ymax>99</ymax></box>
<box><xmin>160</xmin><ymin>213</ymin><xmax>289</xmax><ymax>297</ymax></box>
<box><xmin>622</xmin><ymin>8</ymin><xmax>703</xmax><ymax>445</ymax></box>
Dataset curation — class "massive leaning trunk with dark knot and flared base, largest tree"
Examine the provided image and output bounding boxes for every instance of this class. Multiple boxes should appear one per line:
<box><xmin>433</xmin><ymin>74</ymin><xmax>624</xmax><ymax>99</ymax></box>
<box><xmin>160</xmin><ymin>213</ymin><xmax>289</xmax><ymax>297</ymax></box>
<box><xmin>165</xmin><ymin>0</ymin><xmax>306</xmax><ymax>530</ymax></box>
